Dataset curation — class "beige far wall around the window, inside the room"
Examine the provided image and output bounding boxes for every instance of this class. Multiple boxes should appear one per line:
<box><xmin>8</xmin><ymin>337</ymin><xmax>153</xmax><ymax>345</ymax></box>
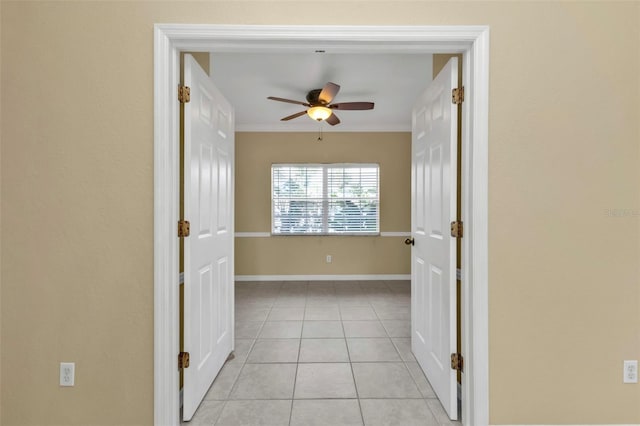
<box><xmin>235</xmin><ymin>132</ymin><xmax>411</xmax><ymax>275</ymax></box>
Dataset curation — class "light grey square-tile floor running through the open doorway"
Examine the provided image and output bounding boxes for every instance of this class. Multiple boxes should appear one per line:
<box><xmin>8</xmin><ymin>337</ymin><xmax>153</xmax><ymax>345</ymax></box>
<box><xmin>185</xmin><ymin>281</ymin><xmax>460</xmax><ymax>426</ymax></box>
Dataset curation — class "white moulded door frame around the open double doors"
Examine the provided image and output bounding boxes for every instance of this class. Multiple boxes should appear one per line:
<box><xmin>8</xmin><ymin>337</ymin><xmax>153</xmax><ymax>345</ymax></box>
<box><xmin>153</xmin><ymin>24</ymin><xmax>489</xmax><ymax>425</ymax></box>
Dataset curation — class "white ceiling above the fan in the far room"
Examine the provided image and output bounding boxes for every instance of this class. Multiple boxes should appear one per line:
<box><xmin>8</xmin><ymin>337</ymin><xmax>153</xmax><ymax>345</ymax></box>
<box><xmin>210</xmin><ymin>53</ymin><xmax>433</xmax><ymax>132</ymax></box>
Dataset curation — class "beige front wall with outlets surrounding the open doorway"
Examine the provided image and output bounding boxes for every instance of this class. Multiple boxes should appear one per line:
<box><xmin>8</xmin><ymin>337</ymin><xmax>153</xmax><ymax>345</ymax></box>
<box><xmin>0</xmin><ymin>1</ymin><xmax>640</xmax><ymax>425</ymax></box>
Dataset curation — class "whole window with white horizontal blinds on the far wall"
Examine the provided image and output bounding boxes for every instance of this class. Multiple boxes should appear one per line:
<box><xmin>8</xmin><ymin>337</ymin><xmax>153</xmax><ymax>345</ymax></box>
<box><xmin>271</xmin><ymin>164</ymin><xmax>380</xmax><ymax>235</ymax></box>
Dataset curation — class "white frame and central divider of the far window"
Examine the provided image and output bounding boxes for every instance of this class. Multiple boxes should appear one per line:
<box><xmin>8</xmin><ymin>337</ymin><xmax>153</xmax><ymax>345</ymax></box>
<box><xmin>269</xmin><ymin>162</ymin><xmax>381</xmax><ymax>237</ymax></box>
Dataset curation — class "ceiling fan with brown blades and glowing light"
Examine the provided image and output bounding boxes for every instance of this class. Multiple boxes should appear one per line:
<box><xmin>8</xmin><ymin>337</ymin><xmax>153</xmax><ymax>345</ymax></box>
<box><xmin>267</xmin><ymin>82</ymin><xmax>374</xmax><ymax>126</ymax></box>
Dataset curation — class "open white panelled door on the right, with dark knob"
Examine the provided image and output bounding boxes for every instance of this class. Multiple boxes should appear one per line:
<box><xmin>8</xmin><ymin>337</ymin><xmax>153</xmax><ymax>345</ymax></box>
<box><xmin>411</xmin><ymin>58</ymin><xmax>458</xmax><ymax>420</ymax></box>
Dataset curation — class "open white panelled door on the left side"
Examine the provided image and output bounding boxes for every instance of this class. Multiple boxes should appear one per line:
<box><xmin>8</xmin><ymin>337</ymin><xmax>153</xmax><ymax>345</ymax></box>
<box><xmin>183</xmin><ymin>55</ymin><xmax>234</xmax><ymax>420</ymax></box>
